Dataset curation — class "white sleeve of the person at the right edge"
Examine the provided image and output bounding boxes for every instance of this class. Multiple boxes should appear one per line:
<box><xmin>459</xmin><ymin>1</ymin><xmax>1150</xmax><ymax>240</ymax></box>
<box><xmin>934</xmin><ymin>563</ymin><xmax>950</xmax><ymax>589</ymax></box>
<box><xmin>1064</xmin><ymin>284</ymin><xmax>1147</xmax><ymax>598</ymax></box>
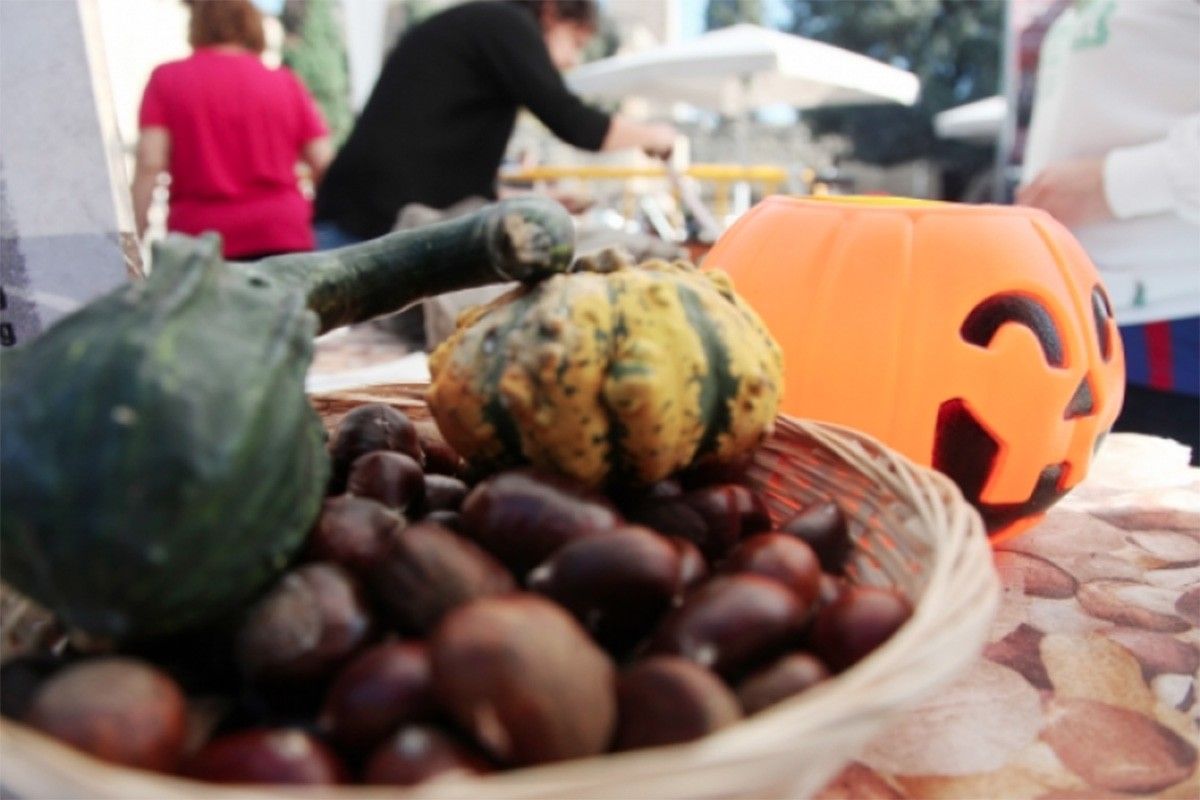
<box><xmin>1104</xmin><ymin>114</ymin><xmax>1200</xmax><ymax>222</ymax></box>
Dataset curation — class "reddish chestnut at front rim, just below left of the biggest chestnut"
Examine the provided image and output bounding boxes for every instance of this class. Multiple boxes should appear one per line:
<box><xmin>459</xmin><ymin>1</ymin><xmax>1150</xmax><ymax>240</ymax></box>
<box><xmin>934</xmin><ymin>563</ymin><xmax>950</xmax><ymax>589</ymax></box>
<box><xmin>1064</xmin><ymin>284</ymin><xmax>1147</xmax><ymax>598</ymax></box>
<box><xmin>362</xmin><ymin>724</ymin><xmax>492</xmax><ymax>786</ymax></box>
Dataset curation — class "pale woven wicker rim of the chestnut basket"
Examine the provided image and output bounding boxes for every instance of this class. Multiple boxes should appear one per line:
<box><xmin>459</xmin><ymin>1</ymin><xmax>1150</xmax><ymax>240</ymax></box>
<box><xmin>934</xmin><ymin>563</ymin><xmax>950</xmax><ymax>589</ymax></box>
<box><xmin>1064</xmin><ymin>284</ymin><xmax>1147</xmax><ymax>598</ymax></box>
<box><xmin>0</xmin><ymin>384</ymin><xmax>1000</xmax><ymax>800</ymax></box>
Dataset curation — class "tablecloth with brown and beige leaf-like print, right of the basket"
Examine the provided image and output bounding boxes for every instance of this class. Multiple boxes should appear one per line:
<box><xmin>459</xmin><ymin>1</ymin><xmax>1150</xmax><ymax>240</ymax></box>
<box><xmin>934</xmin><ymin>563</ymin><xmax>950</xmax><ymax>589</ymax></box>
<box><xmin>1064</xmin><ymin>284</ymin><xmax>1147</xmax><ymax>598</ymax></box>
<box><xmin>820</xmin><ymin>434</ymin><xmax>1200</xmax><ymax>800</ymax></box>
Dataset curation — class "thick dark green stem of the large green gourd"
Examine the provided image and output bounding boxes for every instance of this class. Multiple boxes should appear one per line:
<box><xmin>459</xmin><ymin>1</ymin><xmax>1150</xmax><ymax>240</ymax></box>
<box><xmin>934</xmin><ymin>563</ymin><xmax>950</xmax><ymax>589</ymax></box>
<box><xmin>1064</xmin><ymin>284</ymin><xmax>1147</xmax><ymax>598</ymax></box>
<box><xmin>240</xmin><ymin>197</ymin><xmax>575</xmax><ymax>333</ymax></box>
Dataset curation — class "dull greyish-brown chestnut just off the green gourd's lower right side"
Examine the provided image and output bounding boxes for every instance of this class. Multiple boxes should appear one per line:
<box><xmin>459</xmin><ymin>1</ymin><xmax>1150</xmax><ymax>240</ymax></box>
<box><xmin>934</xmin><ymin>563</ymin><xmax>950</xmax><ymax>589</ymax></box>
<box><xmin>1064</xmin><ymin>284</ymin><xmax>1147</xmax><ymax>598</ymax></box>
<box><xmin>234</xmin><ymin>561</ymin><xmax>373</xmax><ymax>682</ymax></box>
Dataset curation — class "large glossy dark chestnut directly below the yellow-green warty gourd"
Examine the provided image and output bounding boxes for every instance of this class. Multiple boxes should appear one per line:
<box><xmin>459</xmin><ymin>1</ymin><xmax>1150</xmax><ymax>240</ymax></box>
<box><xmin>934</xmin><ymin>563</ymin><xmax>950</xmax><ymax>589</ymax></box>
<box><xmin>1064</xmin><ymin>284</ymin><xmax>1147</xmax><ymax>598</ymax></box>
<box><xmin>462</xmin><ymin>469</ymin><xmax>620</xmax><ymax>577</ymax></box>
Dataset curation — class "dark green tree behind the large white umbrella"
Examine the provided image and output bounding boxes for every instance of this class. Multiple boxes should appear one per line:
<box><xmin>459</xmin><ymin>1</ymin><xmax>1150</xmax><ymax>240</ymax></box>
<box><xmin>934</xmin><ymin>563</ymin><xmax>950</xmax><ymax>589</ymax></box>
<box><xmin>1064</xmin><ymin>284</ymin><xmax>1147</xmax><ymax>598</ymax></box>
<box><xmin>788</xmin><ymin>0</ymin><xmax>1004</xmax><ymax>184</ymax></box>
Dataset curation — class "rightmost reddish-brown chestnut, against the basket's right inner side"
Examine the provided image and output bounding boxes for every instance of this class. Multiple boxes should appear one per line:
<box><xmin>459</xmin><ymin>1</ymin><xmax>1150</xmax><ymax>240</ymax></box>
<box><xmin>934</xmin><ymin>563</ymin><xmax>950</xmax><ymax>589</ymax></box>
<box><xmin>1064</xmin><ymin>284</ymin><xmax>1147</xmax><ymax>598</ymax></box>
<box><xmin>811</xmin><ymin>587</ymin><xmax>912</xmax><ymax>672</ymax></box>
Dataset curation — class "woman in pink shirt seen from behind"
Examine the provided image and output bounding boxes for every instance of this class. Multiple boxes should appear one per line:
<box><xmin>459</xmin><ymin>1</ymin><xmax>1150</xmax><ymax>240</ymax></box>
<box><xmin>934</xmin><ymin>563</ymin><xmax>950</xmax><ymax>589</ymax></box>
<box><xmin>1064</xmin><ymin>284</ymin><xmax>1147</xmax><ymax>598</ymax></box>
<box><xmin>133</xmin><ymin>0</ymin><xmax>332</xmax><ymax>260</ymax></box>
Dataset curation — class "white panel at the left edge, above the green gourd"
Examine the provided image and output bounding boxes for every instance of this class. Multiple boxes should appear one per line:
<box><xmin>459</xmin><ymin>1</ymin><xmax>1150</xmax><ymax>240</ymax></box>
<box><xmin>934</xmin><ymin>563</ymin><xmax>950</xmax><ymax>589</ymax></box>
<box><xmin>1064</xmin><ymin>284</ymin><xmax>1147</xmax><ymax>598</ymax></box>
<box><xmin>0</xmin><ymin>0</ymin><xmax>133</xmax><ymax>344</ymax></box>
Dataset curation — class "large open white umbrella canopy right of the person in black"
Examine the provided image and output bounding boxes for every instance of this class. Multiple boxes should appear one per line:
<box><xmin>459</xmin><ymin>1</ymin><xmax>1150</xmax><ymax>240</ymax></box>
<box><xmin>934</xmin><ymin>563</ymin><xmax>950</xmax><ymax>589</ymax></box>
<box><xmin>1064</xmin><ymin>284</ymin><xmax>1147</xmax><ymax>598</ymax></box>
<box><xmin>566</xmin><ymin>24</ymin><xmax>919</xmax><ymax>115</ymax></box>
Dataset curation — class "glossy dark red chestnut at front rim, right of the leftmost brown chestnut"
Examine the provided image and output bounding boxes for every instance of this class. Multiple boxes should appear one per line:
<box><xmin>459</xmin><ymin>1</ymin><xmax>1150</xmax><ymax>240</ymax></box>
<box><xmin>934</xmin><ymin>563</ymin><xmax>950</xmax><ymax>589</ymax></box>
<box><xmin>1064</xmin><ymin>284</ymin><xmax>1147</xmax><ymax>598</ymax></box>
<box><xmin>182</xmin><ymin>728</ymin><xmax>348</xmax><ymax>786</ymax></box>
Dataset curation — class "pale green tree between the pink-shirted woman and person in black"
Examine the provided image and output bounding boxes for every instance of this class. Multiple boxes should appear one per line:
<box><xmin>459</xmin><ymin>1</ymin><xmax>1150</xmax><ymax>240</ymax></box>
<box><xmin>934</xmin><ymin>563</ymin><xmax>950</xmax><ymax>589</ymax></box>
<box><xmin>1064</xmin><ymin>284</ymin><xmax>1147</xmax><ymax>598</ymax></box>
<box><xmin>282</xmin><ymin>0</ymin><xmax>354</xmax><ymax>146</ymax></box>
